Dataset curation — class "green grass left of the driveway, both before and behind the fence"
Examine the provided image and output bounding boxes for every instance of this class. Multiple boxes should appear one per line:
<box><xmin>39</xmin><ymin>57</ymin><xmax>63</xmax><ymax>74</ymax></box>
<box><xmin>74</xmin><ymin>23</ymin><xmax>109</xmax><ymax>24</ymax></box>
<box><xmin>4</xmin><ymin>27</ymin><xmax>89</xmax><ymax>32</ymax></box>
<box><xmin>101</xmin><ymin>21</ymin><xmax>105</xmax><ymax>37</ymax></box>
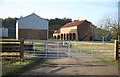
<box><xmin>2</xmin><ymin>39</ymin><xmax>45</xmax><ymax>76</ymax></box>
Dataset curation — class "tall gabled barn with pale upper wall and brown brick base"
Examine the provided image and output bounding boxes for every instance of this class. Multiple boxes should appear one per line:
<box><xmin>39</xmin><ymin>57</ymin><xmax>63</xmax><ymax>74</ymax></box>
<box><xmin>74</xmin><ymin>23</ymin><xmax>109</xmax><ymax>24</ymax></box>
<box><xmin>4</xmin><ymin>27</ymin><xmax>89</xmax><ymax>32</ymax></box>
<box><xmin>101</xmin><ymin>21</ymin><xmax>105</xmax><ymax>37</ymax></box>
<box><xmin>16</xmin><ymin>13</ymin><xmax>48</xmax><ymax>40</ymax></box>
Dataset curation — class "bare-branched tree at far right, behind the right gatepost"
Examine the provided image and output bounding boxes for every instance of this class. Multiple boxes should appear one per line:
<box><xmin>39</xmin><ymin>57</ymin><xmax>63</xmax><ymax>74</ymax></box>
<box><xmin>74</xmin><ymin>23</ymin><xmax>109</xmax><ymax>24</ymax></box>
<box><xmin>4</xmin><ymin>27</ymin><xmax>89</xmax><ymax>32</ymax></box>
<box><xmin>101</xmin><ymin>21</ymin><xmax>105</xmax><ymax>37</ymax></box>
<box><xmin>98</xmin><ymin>14</ymin><xmax>119</xmax><ymax>39</ymax></box>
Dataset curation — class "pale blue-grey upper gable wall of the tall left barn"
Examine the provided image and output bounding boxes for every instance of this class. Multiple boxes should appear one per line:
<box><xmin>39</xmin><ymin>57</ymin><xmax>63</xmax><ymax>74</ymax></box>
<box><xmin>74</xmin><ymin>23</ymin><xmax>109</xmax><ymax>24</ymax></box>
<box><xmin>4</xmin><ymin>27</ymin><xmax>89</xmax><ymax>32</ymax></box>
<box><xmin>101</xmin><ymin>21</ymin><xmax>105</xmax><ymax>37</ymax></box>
<box><xmin>18</xmin><ymin>14</ymin><xmax>48</xmax><ymax>29</ymax></box>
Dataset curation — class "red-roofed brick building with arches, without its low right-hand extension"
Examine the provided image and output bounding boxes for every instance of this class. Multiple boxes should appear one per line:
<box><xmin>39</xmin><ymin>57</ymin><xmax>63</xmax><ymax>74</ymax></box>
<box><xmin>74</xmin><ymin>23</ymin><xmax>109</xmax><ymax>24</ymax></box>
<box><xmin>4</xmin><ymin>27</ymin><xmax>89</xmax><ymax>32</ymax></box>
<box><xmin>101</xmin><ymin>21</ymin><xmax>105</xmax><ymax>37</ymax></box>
<box><xmin>53</xmin><ymin>20</ymin><xmax>93</xmax><ymax>41</ymax></box>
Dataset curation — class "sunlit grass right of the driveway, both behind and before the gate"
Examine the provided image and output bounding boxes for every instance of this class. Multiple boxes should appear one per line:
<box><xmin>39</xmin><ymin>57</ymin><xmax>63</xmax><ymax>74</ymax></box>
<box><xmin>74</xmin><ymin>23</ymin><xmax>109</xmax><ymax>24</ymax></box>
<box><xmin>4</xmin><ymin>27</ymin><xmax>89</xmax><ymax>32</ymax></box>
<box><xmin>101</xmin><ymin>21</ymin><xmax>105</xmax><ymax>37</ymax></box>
<box><xmin>71</xmin><ymin>42</ymin><xmax>120</xmax><ymax>67</ymax></box>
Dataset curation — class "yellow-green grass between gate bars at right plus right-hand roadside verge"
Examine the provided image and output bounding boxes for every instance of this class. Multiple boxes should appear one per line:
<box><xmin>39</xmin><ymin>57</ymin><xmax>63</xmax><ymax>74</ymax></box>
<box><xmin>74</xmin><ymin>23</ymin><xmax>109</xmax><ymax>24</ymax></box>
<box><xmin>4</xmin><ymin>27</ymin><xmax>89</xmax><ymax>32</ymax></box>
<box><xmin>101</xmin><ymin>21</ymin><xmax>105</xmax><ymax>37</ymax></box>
<box><xmin>71</xmin><ymin>42</ymin><xmax>120</xmax><ymax>67</ymax></box>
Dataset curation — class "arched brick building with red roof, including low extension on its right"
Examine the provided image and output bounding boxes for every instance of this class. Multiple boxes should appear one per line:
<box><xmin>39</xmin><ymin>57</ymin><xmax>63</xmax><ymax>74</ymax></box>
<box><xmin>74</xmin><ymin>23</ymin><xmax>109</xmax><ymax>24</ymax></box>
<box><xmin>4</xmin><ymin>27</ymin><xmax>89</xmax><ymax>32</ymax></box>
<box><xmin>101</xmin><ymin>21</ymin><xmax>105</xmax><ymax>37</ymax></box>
<box><xmin>53</xmin><ymin>20</ymin><xmax>111</xmax><ymax>41</ymax></box>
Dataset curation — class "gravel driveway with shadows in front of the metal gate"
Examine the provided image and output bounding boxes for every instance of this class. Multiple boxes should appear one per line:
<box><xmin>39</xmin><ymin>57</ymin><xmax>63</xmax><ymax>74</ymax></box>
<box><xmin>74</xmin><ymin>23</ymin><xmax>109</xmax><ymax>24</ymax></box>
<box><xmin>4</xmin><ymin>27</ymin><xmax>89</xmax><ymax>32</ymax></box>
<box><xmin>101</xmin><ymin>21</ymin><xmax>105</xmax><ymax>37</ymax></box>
<box><xmin>21</xmin><ymin>41</ymin><xmax>118</xmax><ymax>75</ymax></box>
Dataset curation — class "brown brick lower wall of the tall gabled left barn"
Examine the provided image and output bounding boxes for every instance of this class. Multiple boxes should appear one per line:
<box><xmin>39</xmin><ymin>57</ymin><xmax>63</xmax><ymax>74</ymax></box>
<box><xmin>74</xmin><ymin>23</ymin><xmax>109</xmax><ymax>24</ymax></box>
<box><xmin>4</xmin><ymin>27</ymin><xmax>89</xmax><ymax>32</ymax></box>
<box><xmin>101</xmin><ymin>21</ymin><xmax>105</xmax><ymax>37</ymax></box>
<box><xmin>19</xmin><ymin>29</ymin><xmax>47</xmax><ymax>40</ymax></box>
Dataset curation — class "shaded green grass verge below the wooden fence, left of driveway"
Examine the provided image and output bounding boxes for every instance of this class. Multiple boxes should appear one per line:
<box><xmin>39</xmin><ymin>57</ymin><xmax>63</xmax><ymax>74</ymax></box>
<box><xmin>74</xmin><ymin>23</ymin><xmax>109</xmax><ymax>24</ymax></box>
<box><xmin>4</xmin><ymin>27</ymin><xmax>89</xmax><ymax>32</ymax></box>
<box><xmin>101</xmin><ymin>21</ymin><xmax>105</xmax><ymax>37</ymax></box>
<box><xmin>2</xmin><ymin>58</ymin><xmax>40</xmax><ymax>76</ymax></box>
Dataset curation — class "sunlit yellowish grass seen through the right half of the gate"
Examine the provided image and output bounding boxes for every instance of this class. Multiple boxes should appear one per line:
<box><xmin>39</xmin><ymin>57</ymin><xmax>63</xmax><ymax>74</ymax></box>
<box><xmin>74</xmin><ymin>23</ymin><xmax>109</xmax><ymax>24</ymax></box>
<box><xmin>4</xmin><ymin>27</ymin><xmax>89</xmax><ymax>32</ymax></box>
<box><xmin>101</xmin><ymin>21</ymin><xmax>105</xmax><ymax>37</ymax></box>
<box><xmin>72</xmin><ymin>42</ymin><xmax>114</xmax><ymax>57</ymax></box>
